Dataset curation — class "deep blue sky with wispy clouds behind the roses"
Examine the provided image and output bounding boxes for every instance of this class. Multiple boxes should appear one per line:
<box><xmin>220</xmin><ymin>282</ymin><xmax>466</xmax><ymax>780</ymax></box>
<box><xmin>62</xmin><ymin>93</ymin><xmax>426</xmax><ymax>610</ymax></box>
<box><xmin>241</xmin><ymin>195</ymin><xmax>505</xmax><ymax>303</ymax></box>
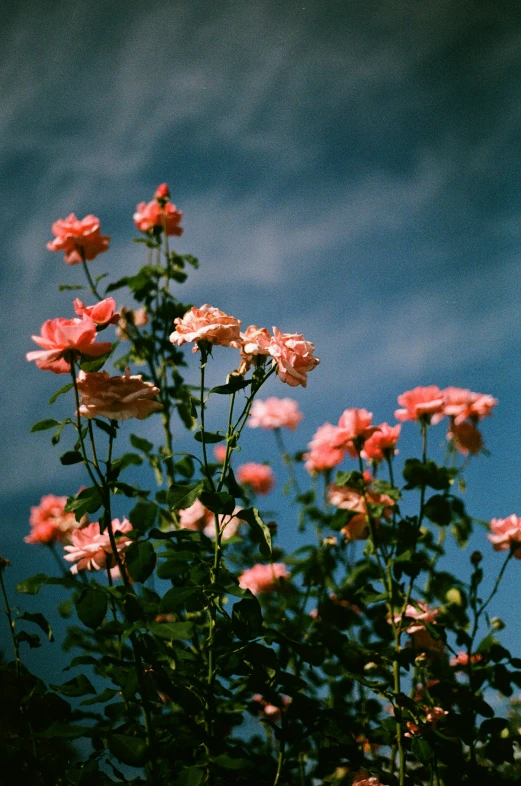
<box><xmin>0</xmin><ymin>0</ymin><xmax>521</xmax><ymax>668</ymax></box>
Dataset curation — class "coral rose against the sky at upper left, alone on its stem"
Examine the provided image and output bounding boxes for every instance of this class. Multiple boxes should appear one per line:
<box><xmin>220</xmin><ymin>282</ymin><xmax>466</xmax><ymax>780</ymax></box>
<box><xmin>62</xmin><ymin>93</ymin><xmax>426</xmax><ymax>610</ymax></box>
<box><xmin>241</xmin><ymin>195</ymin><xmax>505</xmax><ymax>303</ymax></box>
<box><xmin>47</xmin><ymin>213</ymin><xmax>110</xmax><ymax>265</ymax></box>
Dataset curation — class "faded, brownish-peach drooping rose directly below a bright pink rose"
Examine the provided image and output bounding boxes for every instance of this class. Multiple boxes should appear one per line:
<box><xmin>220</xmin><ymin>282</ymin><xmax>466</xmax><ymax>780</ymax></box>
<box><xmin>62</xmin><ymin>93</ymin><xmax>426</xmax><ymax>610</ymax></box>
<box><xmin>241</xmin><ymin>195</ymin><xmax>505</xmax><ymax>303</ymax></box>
<box><xmin>78</xmin><ymin>368</ymin><xmax>163</xmax><ymax>420</ymax></box>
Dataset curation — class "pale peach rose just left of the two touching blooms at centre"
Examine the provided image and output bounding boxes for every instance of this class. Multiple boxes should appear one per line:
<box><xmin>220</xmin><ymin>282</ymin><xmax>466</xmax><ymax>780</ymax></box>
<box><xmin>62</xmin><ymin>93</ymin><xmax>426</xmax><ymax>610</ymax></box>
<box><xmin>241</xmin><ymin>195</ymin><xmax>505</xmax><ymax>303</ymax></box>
<box><xmin>170</xmin><ymin>304</ymin><xmax>241</xmax><ymax>352</ymax></box>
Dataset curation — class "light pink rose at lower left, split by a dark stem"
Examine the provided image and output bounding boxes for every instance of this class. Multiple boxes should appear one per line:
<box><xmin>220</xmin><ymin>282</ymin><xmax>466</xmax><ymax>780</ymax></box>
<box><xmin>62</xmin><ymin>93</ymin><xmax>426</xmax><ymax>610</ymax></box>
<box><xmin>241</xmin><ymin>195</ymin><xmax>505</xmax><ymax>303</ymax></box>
<box><xmin>64</xmin><ymin>519</ymin><xmax>132</xmax><ymax>573</ymax></box>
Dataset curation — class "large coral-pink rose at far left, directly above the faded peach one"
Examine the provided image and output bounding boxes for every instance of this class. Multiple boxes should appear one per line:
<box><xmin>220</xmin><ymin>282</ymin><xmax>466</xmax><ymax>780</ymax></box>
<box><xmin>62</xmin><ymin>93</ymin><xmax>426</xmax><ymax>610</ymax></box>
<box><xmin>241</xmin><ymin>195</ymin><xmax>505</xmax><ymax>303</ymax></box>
<box><xmin>25</xmin><ymin>314</ymin><xmax>112</xmax><ymax>374</ymax></box>
